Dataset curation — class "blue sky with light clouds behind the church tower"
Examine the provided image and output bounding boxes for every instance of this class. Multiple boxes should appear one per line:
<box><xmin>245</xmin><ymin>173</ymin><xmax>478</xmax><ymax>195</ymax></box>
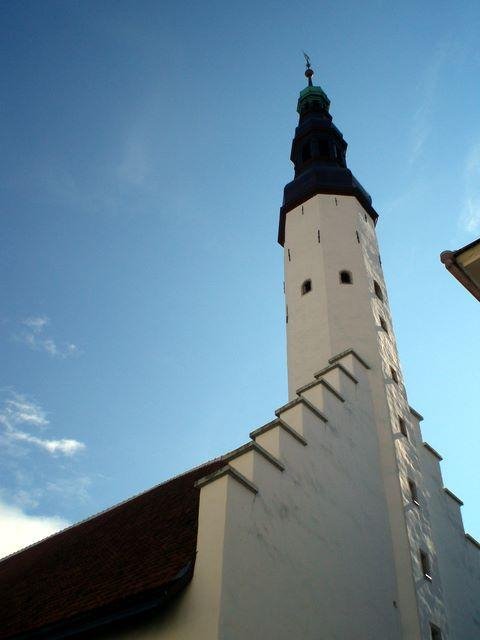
<box><xmin>0</xmin><ymin>0</ymin><xmax>480</xmax><ymax>552</ymax></box>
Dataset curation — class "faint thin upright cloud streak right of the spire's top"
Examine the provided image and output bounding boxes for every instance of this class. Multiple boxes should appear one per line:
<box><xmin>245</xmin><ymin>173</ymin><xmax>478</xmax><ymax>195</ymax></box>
<box><xmin>409</xmin><ymin>41</ymin><xmax>451</xmax><ymax>165</ymax></box>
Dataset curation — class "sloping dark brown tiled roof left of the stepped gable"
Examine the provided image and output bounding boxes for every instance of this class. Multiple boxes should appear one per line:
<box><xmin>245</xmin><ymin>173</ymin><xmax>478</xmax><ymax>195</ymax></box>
<box><xmin>0</xmin><ymin>460</ymin><xmax>225</xmax><ymax>639</ymax></box>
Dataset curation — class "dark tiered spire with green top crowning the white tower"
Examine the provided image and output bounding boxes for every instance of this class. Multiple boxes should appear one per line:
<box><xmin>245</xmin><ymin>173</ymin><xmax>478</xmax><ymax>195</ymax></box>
<box><xmin>278</xmin><ymin>62</ymin><xmax>378</xmax><ymax>245</ymax></box>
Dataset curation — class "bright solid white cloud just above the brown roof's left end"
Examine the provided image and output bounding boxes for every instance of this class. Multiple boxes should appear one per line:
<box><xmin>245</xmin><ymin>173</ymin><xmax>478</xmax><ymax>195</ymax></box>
<box><xmin>0</xmin><ymin>499</ymin><xmax>70</xmax><ymax>558</ymax></box>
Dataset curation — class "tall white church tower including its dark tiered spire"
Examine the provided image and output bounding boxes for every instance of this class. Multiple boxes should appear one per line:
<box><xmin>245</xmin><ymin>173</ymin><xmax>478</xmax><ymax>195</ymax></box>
<box><xmin>278</xmin><ymin>57</ymin><xmax>473</xmax><ymax>640</ymax></box>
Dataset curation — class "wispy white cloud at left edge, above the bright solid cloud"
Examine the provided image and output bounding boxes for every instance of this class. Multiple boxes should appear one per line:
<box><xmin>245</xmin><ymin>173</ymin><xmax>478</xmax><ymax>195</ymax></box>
<box><xmin>0</xmin><ymin>391</ymin><xmax>85</xmax><ymax>456</ymax></box>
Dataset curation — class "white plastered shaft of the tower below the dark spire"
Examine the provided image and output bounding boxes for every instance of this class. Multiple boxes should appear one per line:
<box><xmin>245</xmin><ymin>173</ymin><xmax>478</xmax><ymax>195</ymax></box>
<box><xmin>284</xmin><ymin>195</ymin><xmax>445</xmax><ymax>640</ymax></box>
